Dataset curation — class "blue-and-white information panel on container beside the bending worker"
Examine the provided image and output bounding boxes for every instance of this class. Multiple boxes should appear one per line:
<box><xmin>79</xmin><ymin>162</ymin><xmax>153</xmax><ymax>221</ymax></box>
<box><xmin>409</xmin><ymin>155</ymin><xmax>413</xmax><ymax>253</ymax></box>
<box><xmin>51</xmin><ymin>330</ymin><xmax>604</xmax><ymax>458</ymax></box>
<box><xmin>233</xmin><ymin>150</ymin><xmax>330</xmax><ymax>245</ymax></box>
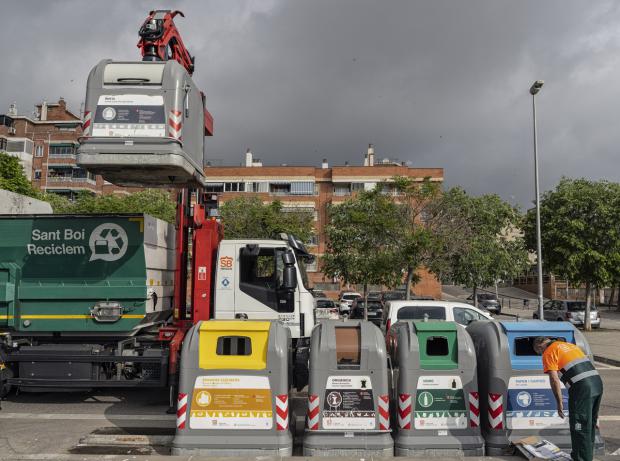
<box><xmin>506</xmin><ymin>375</ymin><xmax>568</xmax><ymax>429</ymax></box>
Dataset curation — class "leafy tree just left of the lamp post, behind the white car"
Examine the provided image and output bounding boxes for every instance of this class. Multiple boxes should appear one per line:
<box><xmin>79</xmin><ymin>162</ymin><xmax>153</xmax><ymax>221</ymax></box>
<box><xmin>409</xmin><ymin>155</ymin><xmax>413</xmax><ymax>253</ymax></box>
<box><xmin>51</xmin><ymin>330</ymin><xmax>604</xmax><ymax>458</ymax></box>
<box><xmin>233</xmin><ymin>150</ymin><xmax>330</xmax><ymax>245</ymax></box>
<box><xmin>443</xmin><ymin>188</ymin><xmax>529</xmax><ymax>304</ymax></box>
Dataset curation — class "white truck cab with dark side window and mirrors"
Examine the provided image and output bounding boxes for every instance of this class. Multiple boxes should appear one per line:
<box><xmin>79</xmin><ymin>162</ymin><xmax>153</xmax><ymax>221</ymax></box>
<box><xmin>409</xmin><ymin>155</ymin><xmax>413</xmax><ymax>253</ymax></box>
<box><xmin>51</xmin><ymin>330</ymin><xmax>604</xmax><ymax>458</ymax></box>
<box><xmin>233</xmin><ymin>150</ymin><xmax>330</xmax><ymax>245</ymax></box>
<box><xmin>214</xmin><ymin>234</ymin><xmax>315</xmax><ymax>339</ymax></box>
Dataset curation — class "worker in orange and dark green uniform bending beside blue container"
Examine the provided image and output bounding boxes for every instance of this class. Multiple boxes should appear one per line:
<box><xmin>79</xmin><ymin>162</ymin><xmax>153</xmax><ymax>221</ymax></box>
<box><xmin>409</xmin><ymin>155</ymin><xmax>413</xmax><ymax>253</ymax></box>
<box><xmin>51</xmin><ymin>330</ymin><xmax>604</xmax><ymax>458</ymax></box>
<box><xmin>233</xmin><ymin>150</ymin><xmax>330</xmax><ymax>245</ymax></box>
<box><xmin>532</xmin><ymin>336</ymin><xmax>603</xmax><ymax>461</ymax></box>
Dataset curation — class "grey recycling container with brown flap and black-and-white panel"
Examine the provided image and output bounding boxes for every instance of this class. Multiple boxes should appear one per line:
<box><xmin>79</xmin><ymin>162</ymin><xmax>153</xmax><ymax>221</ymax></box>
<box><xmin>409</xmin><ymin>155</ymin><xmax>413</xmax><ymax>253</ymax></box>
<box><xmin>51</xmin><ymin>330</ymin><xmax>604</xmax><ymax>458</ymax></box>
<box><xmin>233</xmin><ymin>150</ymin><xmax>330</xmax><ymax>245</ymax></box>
<box><xmin>303</xmin><ymin>320</ymin><xmax>394</xmax><ymax>457</ymax></box>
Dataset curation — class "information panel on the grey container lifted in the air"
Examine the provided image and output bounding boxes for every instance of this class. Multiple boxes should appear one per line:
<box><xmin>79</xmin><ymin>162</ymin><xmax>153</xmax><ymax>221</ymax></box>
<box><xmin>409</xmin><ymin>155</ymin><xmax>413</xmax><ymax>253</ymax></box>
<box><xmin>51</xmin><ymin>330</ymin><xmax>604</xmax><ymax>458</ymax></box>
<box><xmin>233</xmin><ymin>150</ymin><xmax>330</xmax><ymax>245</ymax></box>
<box><xmin>92</xmin><ymin>94</ymin><xmax>166</xmax><ymax>138</ymax></box>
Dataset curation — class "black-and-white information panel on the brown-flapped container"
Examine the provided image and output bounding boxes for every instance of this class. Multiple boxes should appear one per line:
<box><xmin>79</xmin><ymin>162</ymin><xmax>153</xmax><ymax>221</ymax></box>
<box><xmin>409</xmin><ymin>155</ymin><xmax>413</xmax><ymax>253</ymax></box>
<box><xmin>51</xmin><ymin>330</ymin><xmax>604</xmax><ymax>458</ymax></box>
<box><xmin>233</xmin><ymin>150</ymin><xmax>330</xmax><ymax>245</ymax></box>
<box><xmin>322</xmin><ymin>376</ymin><xmax>376</xmax><ymax>430</ymax></box>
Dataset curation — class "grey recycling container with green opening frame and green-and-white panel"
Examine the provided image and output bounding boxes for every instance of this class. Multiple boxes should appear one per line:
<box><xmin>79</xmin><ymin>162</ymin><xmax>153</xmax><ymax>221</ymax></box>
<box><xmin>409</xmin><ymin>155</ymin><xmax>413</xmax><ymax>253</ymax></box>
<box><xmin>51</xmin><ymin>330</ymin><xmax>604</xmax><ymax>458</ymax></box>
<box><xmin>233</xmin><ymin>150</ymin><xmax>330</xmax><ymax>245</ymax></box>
<box><xmin>392</xmin><ymin>321</ymin><xmax>484</xmax><ymax>457</ymax></box>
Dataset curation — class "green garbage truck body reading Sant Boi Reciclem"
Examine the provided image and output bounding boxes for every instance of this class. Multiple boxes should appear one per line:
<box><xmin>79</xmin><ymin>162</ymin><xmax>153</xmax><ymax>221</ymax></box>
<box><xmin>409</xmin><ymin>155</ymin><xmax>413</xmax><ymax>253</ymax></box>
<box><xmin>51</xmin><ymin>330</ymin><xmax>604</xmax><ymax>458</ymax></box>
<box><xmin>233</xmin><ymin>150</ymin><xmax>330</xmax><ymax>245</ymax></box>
<box><xmin>0</xmin><ymin>214</ymin><xmax>175</xmax><ymax>387</ymax></box>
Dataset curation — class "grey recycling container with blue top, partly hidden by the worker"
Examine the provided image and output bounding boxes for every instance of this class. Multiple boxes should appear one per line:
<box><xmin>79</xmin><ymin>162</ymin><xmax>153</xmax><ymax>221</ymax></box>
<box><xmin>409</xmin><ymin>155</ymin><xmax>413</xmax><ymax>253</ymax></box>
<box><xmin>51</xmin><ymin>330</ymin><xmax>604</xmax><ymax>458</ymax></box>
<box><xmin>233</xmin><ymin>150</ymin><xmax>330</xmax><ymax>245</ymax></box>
<box><xmin>467</xmin><ymin>320</ymin><xmax>605</xmax><ymax>456</ymax></box>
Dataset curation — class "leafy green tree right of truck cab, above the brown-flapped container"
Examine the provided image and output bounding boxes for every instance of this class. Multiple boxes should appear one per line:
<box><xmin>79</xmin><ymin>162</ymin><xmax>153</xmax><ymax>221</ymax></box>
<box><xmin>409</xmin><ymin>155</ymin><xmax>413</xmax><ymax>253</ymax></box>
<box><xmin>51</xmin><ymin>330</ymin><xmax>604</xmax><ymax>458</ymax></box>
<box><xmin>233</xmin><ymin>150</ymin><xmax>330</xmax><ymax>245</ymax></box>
<box><xmin>322</xmin><ymin>187</ymin><xmax>405</xmax><ymax>318</ymax></box>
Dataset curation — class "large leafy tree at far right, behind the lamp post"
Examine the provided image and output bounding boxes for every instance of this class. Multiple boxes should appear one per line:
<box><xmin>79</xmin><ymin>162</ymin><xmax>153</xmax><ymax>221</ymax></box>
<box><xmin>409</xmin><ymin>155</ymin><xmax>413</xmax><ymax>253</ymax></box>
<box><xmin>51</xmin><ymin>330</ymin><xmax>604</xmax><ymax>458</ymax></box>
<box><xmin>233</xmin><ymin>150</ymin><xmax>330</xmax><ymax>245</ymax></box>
<box><xmin>525</xmin><ymin>178</ymin><xmax>620</xmax><ymax>330</ymax></box>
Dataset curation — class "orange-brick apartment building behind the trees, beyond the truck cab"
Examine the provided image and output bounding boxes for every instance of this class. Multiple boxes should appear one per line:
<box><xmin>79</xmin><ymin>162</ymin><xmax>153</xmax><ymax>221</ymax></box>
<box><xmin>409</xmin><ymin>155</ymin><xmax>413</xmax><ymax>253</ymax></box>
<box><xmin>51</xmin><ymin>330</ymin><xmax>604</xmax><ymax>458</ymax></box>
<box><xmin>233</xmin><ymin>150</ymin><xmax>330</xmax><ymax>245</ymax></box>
<box><xmin>204</xmin><ymin>145</ymin><xmax>443</xmax><ymax>298</ymax></box>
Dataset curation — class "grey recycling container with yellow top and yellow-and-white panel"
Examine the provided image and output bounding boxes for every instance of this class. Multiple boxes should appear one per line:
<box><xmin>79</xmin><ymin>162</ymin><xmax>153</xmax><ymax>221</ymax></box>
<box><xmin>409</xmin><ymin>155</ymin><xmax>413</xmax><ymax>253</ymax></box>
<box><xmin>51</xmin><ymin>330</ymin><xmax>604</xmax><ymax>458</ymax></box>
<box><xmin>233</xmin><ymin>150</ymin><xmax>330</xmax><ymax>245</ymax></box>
<box><xmin>172</xmin><ymin>320</ymin><xmax>293</xmax><ymax>457</ymax></box>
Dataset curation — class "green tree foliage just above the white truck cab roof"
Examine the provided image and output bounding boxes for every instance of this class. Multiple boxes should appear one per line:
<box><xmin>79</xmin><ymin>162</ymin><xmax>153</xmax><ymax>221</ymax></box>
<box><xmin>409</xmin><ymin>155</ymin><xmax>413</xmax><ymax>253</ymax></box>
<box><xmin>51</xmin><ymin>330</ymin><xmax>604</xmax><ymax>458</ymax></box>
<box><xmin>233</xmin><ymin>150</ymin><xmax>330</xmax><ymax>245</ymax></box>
<box><xmin>220</xmin><ymin>197</ymin><xmax>314</xmax><ymax>242</ymax></box>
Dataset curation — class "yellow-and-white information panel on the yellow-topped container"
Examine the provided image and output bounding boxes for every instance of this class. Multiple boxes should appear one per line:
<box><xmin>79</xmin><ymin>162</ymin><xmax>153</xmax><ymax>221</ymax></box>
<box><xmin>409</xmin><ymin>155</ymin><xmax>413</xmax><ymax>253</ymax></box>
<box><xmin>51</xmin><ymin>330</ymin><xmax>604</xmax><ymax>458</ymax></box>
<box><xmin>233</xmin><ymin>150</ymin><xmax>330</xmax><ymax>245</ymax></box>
<box><xmin>189</xmin><ymin>375</ymin><xmax>273</xmax><ymax>429</ymax></box>
